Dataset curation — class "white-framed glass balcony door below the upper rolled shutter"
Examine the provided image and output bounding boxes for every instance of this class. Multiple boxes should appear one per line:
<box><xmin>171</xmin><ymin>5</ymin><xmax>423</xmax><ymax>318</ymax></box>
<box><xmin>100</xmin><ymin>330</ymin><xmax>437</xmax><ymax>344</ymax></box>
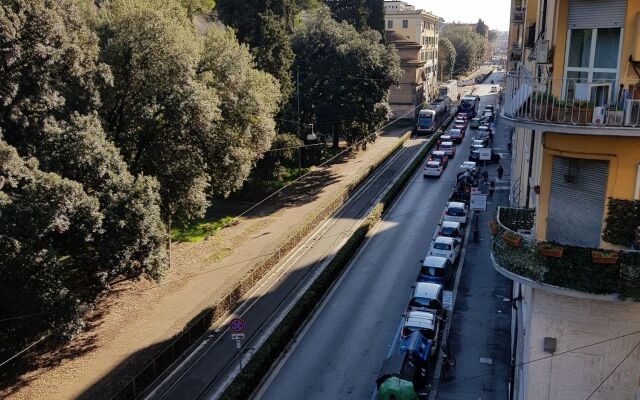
<box><xmin>563</xmin><ymin>28</ymin><xmax>622</xmax><ymax>105</ymax></box>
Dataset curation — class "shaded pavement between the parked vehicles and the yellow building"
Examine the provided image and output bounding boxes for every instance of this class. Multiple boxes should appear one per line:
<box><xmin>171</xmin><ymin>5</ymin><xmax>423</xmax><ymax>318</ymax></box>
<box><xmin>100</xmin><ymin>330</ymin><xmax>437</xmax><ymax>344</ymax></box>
<box><xmin>436</xmin><ymin>99</ymin><xmax>512</xmax><ymax>400</ymax></box>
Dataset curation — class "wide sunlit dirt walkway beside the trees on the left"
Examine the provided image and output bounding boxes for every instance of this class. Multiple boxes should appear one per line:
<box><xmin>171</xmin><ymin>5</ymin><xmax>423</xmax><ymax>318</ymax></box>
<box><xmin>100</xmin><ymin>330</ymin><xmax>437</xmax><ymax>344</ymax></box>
<box><xmin>0</xmin><ymin>127</ymin><xmax>408</xmax><ymax>400</ymax></box>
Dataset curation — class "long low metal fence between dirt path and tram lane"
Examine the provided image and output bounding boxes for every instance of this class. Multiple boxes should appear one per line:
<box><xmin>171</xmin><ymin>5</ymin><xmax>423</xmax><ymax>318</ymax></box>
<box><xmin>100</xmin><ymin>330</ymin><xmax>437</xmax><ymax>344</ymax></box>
<box><xmin>111</xmin><ymin>132</ymin><xmax>410</xmax><ymax>400</ymax></box>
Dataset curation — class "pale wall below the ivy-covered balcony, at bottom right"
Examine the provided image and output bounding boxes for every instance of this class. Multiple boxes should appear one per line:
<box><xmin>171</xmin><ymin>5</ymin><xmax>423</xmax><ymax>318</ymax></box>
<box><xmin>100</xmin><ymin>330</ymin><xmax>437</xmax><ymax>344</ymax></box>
<box><xmin>523</xmin><ymin>290</ymin><xmax>640</xmax><ymax>400</ymax></box>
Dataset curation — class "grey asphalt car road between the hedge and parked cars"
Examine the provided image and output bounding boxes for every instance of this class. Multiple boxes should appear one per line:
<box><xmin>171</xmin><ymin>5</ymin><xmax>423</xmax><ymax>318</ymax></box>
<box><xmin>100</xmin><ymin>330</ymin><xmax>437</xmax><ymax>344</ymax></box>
<box><xmin>256</xmin><ymin>75</ymin><xmax>498</xmax><ymax>400</ymax></box>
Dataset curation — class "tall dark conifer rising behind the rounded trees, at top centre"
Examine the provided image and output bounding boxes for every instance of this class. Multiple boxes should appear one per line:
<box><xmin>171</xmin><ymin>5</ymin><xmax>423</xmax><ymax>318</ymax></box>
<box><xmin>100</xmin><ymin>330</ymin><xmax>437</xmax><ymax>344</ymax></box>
<box><xmin>216</xmin><ymin>0</ymin><xmax>298</xmax><ymax>99</ymax></box>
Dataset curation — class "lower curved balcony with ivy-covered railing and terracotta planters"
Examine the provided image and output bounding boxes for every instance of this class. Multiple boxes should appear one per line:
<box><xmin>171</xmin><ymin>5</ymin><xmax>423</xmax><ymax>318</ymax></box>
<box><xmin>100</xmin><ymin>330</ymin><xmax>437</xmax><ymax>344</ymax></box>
<box><xmin>491</xmin><ymin>207</ymin><xmax>640</xmax><ymax>302</ymax></box>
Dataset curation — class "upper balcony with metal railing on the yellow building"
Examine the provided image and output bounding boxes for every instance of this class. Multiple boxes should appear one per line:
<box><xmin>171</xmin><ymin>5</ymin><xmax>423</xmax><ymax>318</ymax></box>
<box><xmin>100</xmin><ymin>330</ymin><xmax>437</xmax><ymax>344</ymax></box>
<box><xmin>502</xmin><ymin>73</ymin><xmax>640</xmax><ymax>136</ymax></box>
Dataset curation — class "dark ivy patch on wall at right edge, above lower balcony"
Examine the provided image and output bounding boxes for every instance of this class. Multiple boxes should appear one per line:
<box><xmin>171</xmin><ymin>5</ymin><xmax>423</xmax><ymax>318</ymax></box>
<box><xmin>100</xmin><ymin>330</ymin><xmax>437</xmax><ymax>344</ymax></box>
<box><xmin>602</xmin><ymin>198</ymin><xmax>640</xmax><ymax>247</ymax></box>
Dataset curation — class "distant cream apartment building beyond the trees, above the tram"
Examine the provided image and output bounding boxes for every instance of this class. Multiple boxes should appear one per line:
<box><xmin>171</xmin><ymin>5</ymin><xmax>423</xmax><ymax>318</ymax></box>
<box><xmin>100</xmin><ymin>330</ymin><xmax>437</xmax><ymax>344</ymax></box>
<box><xmin>384</xmin><ymin>1</ymin><xmax>443</xmax><ymax>119</ymax></box>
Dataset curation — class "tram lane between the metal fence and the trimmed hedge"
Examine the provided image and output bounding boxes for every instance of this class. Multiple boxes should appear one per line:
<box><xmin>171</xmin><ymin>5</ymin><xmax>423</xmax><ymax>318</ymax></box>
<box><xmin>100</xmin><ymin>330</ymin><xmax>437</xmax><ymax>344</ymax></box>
<box><xmin>146</xmin><ymin>124</ymin><xmax>436</xmax><ymax>400</ymax></box>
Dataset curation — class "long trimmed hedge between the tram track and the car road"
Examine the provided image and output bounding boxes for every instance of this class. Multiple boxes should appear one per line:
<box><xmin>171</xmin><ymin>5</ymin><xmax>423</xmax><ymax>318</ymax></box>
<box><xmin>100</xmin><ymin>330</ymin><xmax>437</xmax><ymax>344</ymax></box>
<box><xmin>221</xmin><ymin>135</ymin><xmax>439</xmax><ymax>400</ymax></box>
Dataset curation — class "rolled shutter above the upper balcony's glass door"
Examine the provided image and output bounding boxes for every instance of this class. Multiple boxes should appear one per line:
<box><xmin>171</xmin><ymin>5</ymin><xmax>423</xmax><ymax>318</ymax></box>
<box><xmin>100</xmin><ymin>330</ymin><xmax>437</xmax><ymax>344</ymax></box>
<box><xmin>569</xmin><ymin>0</ymin><xmax>637</xmax><ymax>29</ymax></box>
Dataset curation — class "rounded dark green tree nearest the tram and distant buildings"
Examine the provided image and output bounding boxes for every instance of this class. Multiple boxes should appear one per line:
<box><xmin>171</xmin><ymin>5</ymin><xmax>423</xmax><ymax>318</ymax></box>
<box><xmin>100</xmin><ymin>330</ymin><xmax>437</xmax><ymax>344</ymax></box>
<box><xmin>292</xmin><ymin>8</ymin><xmax>401</xmax><ymax>146</ymax></box>
